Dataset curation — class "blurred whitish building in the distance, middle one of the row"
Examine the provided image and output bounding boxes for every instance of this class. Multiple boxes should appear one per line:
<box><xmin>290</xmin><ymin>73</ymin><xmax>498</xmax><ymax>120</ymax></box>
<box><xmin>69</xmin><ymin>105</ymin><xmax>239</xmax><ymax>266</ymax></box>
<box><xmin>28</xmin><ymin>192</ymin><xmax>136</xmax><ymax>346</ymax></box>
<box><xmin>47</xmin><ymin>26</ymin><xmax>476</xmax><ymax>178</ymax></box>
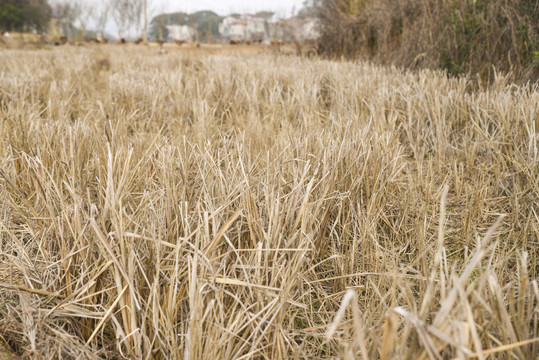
<box><xmin>219</xmin><ymin>15</ymin><xmax>267</xmax><ymax>42</ymax></box>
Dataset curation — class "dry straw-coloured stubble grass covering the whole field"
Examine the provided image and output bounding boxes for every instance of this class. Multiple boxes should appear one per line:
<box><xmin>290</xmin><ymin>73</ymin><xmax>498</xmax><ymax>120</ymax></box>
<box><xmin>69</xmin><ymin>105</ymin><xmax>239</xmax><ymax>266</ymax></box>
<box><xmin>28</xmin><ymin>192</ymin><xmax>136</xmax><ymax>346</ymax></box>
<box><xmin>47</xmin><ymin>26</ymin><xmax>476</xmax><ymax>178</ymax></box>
<box><xmin>0</xmin><ymin>46</ymin><xmax>539</xmax><ymax>359</ymax></box>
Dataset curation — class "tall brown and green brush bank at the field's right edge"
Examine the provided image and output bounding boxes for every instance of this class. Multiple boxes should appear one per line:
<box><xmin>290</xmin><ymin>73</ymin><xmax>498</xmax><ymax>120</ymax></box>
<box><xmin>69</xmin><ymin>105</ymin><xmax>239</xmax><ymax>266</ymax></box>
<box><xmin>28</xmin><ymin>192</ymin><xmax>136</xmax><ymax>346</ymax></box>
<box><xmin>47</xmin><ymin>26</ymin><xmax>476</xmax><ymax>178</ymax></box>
<box><xmin>319</xmin><ymin>0</ymin><xmax>539</xmax><ymax>81</ymax></box>
